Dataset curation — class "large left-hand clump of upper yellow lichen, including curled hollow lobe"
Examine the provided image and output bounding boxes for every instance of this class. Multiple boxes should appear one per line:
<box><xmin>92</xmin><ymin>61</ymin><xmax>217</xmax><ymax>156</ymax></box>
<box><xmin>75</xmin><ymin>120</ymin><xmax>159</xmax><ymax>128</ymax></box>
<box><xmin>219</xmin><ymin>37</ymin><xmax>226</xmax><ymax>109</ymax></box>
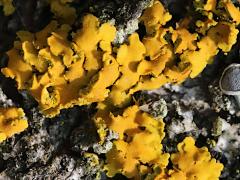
<box><xmin>2</xmin><ymin>15</ymin><xmax>119</xmax><ymax>117</ymax></box>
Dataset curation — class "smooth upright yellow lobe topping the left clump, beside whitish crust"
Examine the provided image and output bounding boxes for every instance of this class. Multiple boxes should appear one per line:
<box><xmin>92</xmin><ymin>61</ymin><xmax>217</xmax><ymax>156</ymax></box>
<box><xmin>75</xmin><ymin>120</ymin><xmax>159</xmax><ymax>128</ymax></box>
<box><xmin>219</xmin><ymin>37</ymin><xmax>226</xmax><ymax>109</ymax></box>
<box><xmin>73</xmin><ymin>14</ymin><xmax>116</xmax><ymax>71</ymax></box>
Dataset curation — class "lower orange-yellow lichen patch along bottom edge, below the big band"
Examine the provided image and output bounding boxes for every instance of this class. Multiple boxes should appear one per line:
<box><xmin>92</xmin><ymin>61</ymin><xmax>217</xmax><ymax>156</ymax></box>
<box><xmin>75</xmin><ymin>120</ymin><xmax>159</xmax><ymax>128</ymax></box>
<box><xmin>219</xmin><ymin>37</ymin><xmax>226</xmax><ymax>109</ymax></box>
<box><xmin>101</xmin><ymin>105</ymin><xmax>223</xmax><ymax>180</ymax></box>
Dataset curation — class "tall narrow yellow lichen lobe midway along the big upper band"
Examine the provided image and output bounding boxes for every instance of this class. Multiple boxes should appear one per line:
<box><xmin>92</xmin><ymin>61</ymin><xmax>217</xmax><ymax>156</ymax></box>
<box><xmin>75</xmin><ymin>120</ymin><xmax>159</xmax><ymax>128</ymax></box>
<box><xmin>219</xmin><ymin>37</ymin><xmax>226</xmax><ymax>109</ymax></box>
<box><xmin>109</xmin><ymin>33</ymin><xmax>146</xmax><ymax>106</ymax></box>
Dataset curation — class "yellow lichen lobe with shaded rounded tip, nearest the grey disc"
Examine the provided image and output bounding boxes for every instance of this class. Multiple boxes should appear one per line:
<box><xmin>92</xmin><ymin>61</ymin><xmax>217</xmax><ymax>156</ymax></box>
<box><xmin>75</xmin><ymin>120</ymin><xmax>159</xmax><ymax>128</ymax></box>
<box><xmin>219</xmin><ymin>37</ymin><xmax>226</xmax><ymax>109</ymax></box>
<box><xmin>180</xmin><ymin>22</ymin><xmax>238</xmax><ymax>78</ymax></box>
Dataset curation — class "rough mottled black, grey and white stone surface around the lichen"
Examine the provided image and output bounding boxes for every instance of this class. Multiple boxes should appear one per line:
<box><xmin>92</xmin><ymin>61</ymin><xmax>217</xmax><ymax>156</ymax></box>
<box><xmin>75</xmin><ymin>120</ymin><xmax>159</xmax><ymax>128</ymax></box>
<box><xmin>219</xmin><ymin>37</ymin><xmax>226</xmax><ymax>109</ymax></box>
<box><xmin>0</xmin><ymin>0</ymin><xmax>240</xmax><ymax>180</ymax></box>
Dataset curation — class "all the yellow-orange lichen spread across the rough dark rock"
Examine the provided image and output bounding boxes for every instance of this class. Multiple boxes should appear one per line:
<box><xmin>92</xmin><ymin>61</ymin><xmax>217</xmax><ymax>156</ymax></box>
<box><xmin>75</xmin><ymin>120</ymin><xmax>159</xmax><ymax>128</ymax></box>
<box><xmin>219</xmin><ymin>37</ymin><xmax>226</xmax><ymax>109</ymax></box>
<box><xmin>0</xmin><ymin>0</ymin><xmax>235</xmax><ymax>180</ymax></box>
